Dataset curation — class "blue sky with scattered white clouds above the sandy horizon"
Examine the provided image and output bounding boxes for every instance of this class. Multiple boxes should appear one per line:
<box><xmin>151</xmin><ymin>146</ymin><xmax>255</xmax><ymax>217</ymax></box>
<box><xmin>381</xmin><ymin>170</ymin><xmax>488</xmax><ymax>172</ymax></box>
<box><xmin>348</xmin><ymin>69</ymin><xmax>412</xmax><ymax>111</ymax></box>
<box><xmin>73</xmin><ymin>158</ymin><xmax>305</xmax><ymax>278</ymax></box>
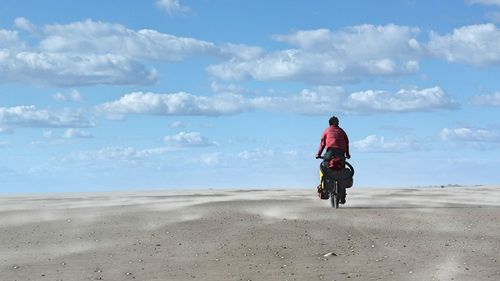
<box><xmin>0</xmin><ymin>0</ymin><xmax>500</xmax><ymax>193</ymax></box>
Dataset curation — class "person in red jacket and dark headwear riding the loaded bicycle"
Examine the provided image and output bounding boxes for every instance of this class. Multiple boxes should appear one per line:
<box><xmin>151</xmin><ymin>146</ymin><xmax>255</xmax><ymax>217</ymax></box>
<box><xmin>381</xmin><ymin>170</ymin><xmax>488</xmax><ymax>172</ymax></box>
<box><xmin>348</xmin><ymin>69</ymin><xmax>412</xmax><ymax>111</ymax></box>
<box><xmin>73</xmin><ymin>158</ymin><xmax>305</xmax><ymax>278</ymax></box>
<box><xmin>316</xmin><ymin>116</ymin><xmax>351</xmax><ymax>204</ymax></box>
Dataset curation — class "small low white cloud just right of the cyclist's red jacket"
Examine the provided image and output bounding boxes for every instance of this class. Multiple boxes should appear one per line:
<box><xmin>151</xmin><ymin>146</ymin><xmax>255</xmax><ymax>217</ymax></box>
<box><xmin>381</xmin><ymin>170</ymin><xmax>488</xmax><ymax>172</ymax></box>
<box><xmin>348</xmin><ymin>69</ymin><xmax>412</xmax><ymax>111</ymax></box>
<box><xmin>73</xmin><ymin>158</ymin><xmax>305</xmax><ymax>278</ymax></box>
<box><xmin>351</xmin><ymin>135</ymin><xmax>422</xmax><ymax>152</ymax></box>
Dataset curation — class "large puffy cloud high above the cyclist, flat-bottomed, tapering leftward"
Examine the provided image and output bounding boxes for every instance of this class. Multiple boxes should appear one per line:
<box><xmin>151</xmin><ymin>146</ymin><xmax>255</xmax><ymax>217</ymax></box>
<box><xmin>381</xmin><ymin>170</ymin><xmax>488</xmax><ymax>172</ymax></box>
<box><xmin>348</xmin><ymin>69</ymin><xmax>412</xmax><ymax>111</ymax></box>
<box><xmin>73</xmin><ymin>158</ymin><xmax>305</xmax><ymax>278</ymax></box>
<box><xmin>208</xmin><ymin>24</ymin><xmax>421</xmax><ymax>84</ymax></box>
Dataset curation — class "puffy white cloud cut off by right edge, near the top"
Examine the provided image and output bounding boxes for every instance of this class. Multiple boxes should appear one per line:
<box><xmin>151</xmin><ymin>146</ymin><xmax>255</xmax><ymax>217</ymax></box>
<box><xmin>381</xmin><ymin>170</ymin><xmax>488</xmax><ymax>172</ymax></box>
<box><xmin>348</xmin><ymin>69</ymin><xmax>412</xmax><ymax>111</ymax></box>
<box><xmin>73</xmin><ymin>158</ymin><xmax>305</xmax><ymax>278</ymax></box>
<box><xmin>427</xmin><ymin>24</ymin><xmax>500</xmax><ymax>66</ymax></box>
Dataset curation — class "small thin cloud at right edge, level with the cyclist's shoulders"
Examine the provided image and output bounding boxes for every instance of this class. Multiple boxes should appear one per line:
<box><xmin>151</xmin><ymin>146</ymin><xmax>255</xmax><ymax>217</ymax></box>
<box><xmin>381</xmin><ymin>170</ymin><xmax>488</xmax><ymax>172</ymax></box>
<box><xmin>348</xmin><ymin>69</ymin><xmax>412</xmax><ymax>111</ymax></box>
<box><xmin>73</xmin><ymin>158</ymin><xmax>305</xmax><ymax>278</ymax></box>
<box><xmin>440</xmin><ymin>128</ymin><xmax>500</xmax><ymax>142</ymax></box>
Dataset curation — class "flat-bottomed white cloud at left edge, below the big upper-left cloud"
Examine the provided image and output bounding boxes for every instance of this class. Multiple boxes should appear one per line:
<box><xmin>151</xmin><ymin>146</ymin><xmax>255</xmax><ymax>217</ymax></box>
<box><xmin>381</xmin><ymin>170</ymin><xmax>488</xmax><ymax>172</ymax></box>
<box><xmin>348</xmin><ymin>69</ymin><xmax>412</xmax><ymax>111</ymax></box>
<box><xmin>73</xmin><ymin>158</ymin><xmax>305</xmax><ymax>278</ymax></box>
<box><xmin>0</xmin><ymin>105</ymin><xmax>95</xmax><ymax>129</ymax></box>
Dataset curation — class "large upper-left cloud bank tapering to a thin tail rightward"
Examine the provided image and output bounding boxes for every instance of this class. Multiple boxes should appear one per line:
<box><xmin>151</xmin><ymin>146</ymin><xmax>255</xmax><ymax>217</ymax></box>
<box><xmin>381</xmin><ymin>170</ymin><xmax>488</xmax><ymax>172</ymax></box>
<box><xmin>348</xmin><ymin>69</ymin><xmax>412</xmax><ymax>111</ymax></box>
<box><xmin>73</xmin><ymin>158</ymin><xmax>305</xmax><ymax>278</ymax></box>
<box><xmin>0</xmin><ymin>18</ymin><xmax>225</xmax><ymax>86</ymax></box>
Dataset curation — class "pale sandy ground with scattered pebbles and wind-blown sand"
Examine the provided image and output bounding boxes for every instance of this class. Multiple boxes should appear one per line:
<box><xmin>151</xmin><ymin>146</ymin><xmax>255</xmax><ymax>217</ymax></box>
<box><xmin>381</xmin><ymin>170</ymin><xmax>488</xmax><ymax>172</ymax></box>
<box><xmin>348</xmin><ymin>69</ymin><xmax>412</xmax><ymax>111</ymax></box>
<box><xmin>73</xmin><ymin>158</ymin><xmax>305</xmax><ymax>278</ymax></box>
<box><xmin>0</xmin><ymin>186</ymin><xmax>500</xmax><ymax>281</ymax></box>
